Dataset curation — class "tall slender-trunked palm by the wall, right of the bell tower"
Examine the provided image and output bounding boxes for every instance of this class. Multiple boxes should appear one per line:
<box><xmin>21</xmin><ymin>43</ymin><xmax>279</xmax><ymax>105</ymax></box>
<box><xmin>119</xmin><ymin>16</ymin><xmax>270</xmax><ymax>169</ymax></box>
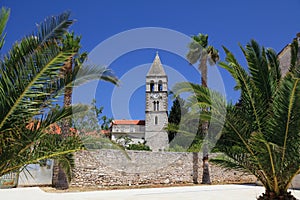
<box><xmin>187</xmin><ymin>33</ymin><xmax>219</xmax><ymax>184</ymax></box>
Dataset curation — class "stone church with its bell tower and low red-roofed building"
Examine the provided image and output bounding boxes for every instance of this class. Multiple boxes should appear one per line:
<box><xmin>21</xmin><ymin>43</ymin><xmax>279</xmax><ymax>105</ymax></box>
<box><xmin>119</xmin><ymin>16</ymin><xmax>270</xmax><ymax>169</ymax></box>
<box><xmin>110</xmin><ymin>53</ymin><xmax>169</xmax><ymax>151</ymax></box>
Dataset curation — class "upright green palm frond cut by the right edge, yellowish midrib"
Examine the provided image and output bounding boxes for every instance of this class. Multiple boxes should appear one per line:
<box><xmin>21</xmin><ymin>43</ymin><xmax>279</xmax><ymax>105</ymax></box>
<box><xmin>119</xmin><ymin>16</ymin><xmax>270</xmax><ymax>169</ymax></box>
<box><xmin>269</xmin><ymin>74</ymin><xmax>300</xmax><ymax>170</ymax></box>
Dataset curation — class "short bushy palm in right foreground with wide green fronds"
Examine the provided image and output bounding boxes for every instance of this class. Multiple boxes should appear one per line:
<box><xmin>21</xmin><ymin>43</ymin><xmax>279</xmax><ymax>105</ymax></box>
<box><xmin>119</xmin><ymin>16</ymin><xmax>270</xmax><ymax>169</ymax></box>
<box><xmin>177</xmin><ymin>40</ymin><xmax>300</xmax><ymax>200</ymax></box>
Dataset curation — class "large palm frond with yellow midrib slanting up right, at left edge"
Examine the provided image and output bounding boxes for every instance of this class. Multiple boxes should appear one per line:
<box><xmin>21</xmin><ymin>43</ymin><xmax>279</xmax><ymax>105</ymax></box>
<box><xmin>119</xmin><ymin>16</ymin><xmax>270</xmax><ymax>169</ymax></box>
<box><xmin>0</xmin><ymin>41</ymin><xmax>73</xmax><ymax>128</ymax></box>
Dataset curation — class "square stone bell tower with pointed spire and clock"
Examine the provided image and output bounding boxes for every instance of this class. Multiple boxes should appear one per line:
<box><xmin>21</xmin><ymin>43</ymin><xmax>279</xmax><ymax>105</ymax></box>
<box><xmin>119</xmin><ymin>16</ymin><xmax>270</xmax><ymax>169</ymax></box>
<box><xmin>145</xmin><ymin>53</ymin><xmax>168</xmax><ymax>151</ymax></box>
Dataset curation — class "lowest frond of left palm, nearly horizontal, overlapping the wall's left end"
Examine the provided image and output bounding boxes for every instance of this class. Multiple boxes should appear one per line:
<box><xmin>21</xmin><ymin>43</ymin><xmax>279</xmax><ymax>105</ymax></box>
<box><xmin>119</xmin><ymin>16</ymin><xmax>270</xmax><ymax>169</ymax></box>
<box><xmin>0</xmin><ymin>129</ymin><xmax>83</xmax><ymax>176</ymax></box>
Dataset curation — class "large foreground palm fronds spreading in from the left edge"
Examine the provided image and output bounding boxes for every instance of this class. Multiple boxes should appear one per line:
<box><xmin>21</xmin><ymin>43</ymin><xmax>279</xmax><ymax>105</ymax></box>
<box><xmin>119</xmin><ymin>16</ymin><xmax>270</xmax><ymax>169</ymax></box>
<box><xmin>0</xmin><ymin>8</ymin><xmax>116</xmax><ymax>180</ymax></box>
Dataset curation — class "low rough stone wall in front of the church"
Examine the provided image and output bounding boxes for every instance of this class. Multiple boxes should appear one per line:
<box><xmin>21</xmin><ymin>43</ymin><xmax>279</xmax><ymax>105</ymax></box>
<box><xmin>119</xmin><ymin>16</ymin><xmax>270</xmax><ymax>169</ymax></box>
<box><xmin>71</xmin><ymin>150</ymin><xmax>256</xmax><ymax>187</ymax></box>
